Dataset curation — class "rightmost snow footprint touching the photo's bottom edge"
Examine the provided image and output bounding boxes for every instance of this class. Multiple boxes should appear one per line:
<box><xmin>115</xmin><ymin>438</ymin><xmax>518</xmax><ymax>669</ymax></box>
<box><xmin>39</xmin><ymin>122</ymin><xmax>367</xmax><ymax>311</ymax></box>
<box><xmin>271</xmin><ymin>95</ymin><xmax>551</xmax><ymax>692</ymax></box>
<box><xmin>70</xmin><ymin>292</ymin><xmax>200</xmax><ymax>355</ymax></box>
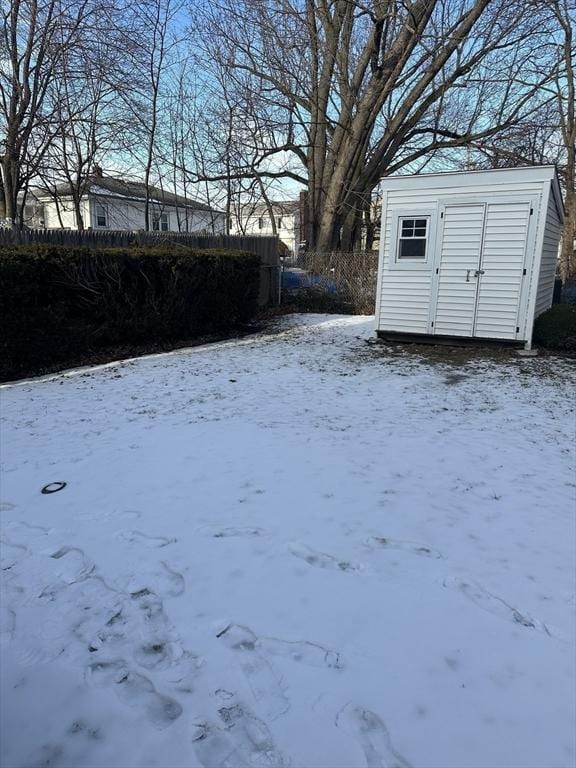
<box><xmin>336</xmin><ymin>705</ymin><xmax>410</xmax><ymax>768</ymax></box>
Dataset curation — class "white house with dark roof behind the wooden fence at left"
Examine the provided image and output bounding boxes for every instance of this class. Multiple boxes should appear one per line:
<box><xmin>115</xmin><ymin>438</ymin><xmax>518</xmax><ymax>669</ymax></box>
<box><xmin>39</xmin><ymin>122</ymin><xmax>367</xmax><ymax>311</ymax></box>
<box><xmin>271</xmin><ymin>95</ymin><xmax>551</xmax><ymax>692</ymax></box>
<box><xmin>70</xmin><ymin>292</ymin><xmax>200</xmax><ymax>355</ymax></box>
<box><xmin>35</xmin><ymin>169</ymin><xmax>225</xmax><ymax>234</ymax></box>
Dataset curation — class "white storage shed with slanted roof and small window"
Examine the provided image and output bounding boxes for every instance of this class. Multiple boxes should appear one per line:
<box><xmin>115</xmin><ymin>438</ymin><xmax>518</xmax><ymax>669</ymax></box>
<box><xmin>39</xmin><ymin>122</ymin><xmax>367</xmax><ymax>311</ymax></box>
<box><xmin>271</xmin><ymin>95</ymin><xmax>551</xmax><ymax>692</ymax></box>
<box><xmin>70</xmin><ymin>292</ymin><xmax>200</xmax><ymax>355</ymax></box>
<box><xmin>376</xmin><ymin>166</ymin><xmax>563</xmax><ymax>348</ymax></box>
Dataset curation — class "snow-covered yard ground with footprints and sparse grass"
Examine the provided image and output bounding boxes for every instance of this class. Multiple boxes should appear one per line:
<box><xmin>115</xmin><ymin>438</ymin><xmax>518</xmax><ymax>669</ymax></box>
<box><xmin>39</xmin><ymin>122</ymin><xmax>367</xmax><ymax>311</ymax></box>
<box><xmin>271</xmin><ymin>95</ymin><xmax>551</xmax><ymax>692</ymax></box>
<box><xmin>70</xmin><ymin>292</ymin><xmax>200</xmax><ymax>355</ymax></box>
<box><xmin>0</xmin><ymin>316</ymin><xmax>576</xmax><ymax>768</ymax></box>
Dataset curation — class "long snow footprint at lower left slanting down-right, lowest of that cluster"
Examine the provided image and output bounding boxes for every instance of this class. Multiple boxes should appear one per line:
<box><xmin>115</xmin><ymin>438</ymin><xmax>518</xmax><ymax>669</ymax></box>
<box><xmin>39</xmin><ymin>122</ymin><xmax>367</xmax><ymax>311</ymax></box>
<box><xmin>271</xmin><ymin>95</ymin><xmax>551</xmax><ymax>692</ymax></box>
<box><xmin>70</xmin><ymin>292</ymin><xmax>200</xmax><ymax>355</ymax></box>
<box><xmin>86</xmin><ymin>660</ymin><xmax>182</xmax><ymax>730</ymax></box>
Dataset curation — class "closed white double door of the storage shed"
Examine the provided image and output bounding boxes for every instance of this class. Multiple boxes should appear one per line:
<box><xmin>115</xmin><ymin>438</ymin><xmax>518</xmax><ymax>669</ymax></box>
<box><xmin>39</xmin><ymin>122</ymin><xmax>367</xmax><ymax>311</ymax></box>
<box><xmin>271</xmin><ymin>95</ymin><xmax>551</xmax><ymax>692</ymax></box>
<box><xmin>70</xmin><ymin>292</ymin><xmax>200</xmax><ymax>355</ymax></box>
<box><xmin>430</xmin><ymin>200</ymin><xmax>532</xmax><ymax>339</ymax></box>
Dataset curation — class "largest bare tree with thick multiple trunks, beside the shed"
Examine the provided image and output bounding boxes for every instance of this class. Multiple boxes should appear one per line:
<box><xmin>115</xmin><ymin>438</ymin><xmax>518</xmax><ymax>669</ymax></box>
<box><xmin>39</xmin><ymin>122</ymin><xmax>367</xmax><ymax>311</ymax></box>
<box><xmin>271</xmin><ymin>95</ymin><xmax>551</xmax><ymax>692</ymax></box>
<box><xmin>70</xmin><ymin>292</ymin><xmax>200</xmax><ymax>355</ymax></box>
<box><xmin>195</xmin><ymin>0</ymin><xmax>551</xmax><ymax>250</ymax></box>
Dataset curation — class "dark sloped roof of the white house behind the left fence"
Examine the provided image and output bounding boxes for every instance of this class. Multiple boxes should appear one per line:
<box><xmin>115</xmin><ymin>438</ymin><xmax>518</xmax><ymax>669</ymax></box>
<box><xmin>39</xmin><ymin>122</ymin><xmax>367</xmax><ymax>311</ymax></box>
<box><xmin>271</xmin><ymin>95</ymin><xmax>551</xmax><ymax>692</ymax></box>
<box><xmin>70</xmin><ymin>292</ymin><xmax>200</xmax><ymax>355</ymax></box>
<box><xmin>36</xmin><ymin>175</ymin><xmax>220</xmax><ymax>213</ymax></box>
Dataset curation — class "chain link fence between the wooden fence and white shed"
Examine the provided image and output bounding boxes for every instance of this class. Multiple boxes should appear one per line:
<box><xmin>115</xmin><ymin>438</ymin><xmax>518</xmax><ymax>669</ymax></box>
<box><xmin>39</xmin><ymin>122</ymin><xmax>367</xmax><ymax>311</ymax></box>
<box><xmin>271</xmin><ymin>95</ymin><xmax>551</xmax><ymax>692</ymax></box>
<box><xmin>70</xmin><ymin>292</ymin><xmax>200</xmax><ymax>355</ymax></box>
<box><xmin>282</xmin><ymin>251</ymin><xmax>378</xmax><ymax>315</ymax></box>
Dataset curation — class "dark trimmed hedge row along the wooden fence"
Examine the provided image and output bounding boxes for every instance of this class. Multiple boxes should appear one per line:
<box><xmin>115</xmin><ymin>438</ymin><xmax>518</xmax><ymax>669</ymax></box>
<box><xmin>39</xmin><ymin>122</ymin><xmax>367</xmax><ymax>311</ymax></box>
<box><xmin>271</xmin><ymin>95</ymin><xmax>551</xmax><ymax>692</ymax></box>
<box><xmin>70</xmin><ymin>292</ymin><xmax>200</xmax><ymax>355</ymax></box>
<box><xmin>0</xmin><ymin>245</ymin><xmax>260</xmax><ymax>379</ymax></box>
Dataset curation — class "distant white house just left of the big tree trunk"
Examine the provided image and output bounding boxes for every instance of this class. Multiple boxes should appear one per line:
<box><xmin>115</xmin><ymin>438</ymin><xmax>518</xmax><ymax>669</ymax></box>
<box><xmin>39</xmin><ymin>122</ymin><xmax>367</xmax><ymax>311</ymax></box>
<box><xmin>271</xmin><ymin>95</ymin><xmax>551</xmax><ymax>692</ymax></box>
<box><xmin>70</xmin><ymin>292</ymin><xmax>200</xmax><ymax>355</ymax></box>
<box><xmin>230</xmin><ymin>200</ymin><xmax>300</xmax><ymax>254</ymax></box>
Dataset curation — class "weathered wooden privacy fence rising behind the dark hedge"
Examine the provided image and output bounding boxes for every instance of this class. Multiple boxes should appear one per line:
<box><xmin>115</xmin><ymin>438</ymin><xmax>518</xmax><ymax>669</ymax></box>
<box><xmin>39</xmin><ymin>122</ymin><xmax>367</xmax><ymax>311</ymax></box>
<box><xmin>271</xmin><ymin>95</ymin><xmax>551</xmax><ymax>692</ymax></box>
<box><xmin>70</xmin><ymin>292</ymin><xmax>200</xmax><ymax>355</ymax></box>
<box><xmin>0</xmin><ymin>228</ymin><xmax>280</xmax><ymax>307</ymax></box>
